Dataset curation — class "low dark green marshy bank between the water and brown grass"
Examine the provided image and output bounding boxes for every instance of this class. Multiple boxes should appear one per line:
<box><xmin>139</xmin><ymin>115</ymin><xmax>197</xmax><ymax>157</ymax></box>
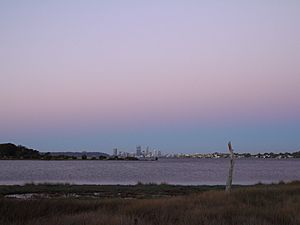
<box><xmin>0</xmin><ymin>183</ymin><xmax>225</xmax><ymax>198</ymax></box>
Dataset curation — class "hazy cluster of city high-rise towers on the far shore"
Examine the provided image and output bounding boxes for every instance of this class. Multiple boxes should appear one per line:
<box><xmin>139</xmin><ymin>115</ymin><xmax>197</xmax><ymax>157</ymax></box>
<box><xmin>113</xmin><ymin>146</ymin><xmax>162</xmax><ymax>158</ymax></box>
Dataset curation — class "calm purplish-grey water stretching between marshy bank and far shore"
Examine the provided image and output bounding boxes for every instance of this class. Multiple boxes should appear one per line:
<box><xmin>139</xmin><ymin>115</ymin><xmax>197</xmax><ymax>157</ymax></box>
<box><xmin>0</xmin><ymin>159</ymin><xmax>300</xmax><ymax>185</ymax></box>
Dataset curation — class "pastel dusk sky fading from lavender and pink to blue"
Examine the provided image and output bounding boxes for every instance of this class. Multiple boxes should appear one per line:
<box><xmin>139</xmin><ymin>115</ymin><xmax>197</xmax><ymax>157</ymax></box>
<box><xmin>0</xmin><ymin>0</ymin><xmax>300</xmax><ymax>153</ymax></box>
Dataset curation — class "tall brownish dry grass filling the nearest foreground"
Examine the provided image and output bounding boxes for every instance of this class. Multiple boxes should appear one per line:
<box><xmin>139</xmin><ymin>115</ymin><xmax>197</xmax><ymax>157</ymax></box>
<box><xmin>0</xmin><ymin>182</ymin><xmax>300</xmax><ymax>225</ymax></box>
